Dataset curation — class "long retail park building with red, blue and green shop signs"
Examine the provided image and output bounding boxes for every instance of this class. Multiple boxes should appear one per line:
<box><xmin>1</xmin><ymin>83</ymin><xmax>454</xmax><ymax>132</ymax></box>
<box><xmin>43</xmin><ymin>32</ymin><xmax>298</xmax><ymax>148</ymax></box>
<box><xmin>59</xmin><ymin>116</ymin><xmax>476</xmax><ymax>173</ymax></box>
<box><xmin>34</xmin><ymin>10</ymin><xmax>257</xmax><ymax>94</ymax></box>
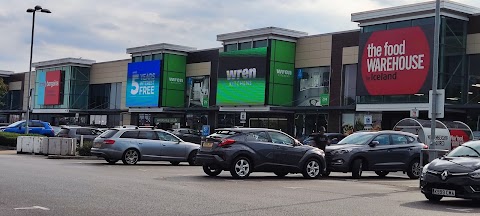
<box><xmin>0</xmin><ymin>1</ymin><xmax>480</xmax><ymax>136</ymax></box>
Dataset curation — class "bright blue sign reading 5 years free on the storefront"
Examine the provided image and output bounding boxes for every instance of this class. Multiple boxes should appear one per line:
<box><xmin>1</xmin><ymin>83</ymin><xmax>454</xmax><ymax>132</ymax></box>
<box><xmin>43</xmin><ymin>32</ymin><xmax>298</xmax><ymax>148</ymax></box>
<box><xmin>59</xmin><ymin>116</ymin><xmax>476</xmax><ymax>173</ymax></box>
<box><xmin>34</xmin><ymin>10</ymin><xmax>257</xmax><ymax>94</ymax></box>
<box><xmin>126</xmin><ymin>60</ymin><xmax>161</xmax><ymax>107</ymax></box>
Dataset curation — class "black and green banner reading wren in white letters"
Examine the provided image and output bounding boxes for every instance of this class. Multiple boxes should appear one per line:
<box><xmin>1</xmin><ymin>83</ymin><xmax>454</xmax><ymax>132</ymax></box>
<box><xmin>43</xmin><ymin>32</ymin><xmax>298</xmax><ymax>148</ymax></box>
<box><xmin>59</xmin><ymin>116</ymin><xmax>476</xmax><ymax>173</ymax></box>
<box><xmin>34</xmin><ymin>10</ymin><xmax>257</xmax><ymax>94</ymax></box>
<box><xmin>217</xmin><ymin>47</ymin><xmax>267</xmax><ymax>105</ymax></box>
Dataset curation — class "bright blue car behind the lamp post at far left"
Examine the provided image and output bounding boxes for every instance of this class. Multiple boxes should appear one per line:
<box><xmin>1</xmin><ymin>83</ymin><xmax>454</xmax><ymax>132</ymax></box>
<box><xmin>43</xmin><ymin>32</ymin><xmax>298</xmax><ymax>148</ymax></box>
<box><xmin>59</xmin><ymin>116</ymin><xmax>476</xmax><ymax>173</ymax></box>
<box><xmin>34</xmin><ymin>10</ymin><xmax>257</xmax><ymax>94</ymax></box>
<box><xmin>2</xmin><ymin>120</ymin><xmax>55</xmax><ymax>137</ymax></box>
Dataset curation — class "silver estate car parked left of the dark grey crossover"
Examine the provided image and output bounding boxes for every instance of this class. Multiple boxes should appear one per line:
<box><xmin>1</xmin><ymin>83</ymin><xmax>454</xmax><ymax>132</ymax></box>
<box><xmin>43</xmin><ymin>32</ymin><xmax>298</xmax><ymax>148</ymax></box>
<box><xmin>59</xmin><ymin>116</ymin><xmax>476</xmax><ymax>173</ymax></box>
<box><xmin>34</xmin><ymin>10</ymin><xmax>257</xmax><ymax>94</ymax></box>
<box><xmin>91</xmin><ymin>128</ymin><xmax>200</xmax><ymax>165</ymax></box>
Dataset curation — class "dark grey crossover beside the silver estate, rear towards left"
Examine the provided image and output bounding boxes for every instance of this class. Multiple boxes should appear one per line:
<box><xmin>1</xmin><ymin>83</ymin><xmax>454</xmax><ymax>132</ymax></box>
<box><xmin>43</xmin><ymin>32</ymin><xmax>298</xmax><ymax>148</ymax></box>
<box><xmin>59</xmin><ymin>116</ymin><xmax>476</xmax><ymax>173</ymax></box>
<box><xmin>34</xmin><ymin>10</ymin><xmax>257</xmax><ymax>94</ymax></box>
<box><xmin>196</xmin><ymin>128</ymin><xmax>325</xmax><ymax>178</ymax></box>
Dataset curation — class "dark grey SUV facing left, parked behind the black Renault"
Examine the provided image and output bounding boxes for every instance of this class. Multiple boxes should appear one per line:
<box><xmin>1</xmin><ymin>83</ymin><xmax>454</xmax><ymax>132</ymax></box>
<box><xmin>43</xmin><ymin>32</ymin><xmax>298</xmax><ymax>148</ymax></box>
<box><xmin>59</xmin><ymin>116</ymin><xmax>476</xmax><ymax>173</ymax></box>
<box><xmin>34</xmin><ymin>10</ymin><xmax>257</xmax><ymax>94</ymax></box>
<box><xmin>325</xmin><ymin>131</ymin><xmax>428</xmax><ymax>179</ymax></box>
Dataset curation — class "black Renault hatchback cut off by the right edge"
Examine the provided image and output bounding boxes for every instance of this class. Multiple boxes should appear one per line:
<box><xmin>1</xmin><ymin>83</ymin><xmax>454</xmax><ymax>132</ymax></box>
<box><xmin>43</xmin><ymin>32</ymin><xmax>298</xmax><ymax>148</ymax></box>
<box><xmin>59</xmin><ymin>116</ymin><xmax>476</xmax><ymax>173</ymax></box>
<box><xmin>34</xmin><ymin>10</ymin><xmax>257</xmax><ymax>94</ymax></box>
<box><xmin>420</xmin><ymin>141</ymin><xmax>480</xmax><ymax>202</ymax></box>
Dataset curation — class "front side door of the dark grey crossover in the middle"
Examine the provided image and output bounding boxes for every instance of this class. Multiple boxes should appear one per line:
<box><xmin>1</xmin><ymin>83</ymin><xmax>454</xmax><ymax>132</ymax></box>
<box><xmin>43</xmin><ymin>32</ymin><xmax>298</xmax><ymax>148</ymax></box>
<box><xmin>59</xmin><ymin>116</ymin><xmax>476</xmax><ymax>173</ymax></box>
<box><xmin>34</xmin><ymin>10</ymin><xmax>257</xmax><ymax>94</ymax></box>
<box><xmin>268</xmin><ymin>131</ymin><xmax>306</xmax><ymax>168</ymax></box>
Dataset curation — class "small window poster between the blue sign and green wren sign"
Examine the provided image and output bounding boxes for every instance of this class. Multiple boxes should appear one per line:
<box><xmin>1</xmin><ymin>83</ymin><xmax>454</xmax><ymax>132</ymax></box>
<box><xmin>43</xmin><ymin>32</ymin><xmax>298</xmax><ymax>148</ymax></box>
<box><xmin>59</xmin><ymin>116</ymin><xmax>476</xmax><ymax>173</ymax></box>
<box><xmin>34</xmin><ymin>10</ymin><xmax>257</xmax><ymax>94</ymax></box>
<box><xmin>187</xmin><ymin>76</ymin><xmax>210</xmax><ymax>107</ymax></box>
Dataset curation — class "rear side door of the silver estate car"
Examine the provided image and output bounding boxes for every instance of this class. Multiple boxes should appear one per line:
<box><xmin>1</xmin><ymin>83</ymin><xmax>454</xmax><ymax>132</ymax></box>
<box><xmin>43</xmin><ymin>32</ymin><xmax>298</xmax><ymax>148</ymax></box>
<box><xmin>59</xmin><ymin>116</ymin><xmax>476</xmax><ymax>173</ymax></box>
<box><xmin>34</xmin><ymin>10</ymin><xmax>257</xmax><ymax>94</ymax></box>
<box><xmin>137</xmin><ymin>131</ymin><xmax>162</xmax><ymax>160</ymax></box>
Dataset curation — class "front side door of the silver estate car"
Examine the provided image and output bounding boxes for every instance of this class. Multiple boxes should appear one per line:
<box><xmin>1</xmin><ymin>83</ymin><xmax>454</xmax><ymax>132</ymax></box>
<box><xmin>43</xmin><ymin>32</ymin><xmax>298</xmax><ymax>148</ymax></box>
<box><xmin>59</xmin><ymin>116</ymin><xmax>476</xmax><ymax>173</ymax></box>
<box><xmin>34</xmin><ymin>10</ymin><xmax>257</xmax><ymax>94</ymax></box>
<box><xmin>156</xmin><ymin>131</ymin><xmax>187</xmax><ymax>159</ymax></box>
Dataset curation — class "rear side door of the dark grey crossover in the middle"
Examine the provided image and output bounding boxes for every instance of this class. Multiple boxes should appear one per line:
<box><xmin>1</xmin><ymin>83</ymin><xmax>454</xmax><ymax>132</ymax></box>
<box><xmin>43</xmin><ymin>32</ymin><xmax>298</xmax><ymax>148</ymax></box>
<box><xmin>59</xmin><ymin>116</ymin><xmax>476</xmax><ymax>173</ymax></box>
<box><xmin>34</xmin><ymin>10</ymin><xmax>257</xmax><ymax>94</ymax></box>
<box><xmin>245</xmin><ymin>131</ymin><xmax>282</xmax><ymax>171</ymax></box>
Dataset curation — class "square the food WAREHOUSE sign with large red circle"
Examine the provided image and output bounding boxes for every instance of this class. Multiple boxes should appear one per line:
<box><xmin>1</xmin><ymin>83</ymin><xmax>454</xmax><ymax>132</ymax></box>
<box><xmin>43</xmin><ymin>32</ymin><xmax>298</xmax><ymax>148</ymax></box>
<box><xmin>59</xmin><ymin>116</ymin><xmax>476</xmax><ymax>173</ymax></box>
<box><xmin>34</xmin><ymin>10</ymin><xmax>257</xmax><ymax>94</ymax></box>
<box><xmin>357</xmin><ymin>25</ymin><xmax>433</xmax><ymax>96</ymax></box>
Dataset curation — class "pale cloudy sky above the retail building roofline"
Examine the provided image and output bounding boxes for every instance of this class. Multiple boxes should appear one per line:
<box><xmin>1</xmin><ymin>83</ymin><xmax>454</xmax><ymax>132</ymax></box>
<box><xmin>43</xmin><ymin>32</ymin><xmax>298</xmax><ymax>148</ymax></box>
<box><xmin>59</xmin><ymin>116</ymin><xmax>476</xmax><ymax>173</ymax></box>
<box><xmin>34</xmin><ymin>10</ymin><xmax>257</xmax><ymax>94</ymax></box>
<box><xmin>0</xmin><ymin>0</ymin><xmax>480</xmax><ymax>72</ymax></box>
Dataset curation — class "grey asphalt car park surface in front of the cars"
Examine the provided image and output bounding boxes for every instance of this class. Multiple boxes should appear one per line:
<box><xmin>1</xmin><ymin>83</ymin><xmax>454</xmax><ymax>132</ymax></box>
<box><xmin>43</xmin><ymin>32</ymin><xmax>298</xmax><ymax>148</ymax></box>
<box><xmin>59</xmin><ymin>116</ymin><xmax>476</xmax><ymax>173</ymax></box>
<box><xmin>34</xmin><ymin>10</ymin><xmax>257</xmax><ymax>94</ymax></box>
<box><xmin>0</xmin><ymin>152</ymin><xmax>480</xmax><ymax>216</ymax></box>
